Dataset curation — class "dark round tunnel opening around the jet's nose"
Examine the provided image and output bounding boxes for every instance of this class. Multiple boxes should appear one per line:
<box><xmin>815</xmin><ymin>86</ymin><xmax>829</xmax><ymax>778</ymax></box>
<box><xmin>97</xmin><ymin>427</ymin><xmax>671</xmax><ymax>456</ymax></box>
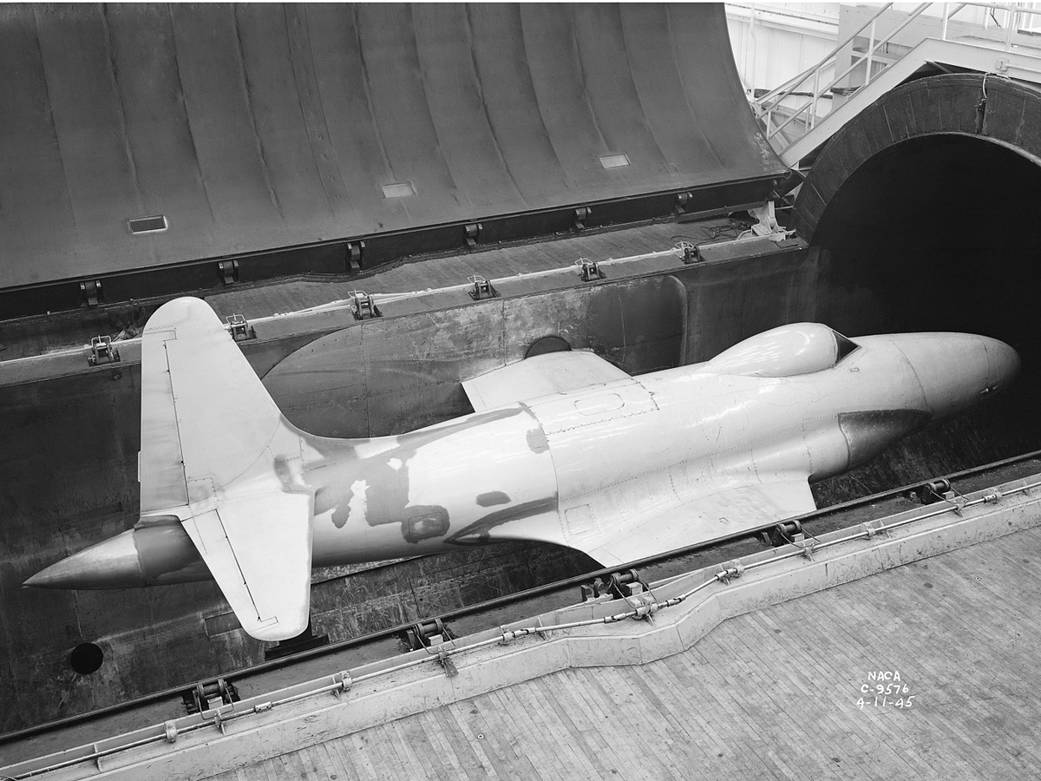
<box><xmin>813</xmin><ymin>133</ymin><xmax>1041</xmax><ymax>495</ymax></box>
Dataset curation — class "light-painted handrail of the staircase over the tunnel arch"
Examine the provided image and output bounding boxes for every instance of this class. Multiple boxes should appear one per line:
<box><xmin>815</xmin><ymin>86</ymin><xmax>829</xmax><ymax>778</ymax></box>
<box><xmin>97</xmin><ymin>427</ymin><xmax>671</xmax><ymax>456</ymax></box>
<box><xmin>752</xmin><ymin>2</ymin><xmax>1041</xmax><ymax>154</ymax></box>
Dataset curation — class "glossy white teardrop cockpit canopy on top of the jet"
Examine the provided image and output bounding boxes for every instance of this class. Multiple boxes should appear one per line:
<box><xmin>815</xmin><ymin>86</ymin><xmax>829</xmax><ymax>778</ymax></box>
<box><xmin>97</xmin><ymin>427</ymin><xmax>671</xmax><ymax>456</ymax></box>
<box><xmin>704</xmin><ymin>323</ymin><xmax>859</xmax><ymax>377</ymax></box>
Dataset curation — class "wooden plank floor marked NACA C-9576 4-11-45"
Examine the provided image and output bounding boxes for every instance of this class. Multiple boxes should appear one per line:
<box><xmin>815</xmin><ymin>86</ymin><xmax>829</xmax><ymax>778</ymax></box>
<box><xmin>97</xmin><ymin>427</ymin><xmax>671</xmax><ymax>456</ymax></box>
<box><xmin>205</xmin><ymin>530</ymin><xmax>1041</xmax><ymax>780</ymax></box>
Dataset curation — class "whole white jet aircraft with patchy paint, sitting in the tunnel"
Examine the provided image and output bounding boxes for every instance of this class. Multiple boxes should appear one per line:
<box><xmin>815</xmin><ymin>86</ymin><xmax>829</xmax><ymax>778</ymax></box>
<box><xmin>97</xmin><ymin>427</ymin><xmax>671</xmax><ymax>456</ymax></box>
<box><xmin>26</xmin><ymin>298</ymin><xmax>1019</xmax><ymax>640</ymax></box>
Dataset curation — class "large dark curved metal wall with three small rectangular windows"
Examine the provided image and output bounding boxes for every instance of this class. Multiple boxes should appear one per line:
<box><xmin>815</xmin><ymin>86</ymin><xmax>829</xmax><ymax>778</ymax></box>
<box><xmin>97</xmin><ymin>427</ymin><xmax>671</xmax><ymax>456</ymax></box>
<box><xmin>0</xmin><ymin>3</ymin><xmax>783</xmax><ymax>288</ymax></box>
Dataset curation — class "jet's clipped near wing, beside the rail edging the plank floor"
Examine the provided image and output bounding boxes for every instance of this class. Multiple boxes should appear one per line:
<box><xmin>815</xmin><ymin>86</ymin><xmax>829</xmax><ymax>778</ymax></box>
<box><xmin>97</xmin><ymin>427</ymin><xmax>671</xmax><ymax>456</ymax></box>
<box><xmin>568</xmin><ymin>473</ymin><xmax>817</xmax><ymax>566</ymax></box>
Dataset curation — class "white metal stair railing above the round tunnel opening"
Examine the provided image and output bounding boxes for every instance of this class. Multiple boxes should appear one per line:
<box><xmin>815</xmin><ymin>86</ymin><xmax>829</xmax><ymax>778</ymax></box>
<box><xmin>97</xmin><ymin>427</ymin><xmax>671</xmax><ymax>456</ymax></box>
<box><xmin>752</xmin><ymin>2</ymin><xmax>1041</xmax><ymax>154</ymax></box>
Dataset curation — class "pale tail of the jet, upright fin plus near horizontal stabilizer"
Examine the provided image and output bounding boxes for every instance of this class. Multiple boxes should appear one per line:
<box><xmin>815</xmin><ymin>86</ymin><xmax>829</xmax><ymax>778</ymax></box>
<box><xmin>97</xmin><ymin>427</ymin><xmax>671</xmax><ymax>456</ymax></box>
<box><xmin>138</xmin><ymin>298</ymin><xmax>313</xmax><ymax>639</ymax></box>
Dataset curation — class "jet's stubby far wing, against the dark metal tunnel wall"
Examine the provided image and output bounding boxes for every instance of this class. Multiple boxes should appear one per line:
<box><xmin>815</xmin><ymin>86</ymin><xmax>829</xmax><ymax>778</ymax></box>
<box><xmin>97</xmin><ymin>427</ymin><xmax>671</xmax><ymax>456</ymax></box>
<box><xmin>462</xmin><ymin>350</ymin><xmax>629</xmax><ymax>412</ymax></box>
